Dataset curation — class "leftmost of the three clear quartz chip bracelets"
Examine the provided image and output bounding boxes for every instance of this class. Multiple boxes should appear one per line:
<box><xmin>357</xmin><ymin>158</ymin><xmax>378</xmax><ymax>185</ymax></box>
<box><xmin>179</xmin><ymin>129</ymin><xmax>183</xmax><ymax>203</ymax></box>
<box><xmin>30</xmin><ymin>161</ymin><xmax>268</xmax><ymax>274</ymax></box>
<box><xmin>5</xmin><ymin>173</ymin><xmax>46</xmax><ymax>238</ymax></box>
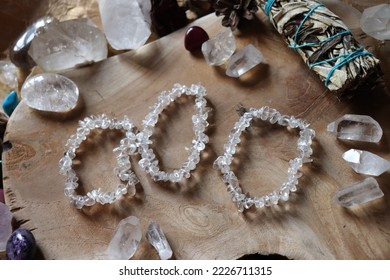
<box><xmin>59</xmin><ymin>114</ymin><xmax>138</xmax><ymax>209</ymax></box>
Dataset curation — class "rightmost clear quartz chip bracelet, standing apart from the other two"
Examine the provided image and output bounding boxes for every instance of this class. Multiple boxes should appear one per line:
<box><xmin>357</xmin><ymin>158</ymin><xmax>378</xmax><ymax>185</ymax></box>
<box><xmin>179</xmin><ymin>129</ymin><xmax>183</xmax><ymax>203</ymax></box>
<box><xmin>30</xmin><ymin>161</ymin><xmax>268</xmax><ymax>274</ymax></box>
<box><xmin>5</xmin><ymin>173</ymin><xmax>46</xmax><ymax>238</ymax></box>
<box><xmin>214</xmin><ymin>106</ymin><xmax>315</xmax><ymax>212</ymax></box>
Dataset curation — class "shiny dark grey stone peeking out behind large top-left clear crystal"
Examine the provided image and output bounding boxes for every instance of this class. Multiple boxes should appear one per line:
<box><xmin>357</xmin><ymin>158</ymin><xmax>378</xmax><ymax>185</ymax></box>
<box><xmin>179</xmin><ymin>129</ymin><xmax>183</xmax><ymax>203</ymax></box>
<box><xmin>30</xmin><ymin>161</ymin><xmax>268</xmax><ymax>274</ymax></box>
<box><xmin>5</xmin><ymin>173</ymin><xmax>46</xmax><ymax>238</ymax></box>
<box><xmin>9</xmin><ymin>16</ymin><xmax>58</xmax><ymax>68</ymax></box>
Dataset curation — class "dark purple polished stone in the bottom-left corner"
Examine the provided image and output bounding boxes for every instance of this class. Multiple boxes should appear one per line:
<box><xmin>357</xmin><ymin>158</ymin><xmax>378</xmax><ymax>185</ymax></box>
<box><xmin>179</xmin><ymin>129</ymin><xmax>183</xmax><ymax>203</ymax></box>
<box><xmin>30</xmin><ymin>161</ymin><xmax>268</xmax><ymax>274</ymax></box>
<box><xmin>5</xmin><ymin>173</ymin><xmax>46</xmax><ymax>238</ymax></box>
<box><xmin>6</xmin><ymin>228</ymin><xmax>37</xmax><ymax>260</ymax></box>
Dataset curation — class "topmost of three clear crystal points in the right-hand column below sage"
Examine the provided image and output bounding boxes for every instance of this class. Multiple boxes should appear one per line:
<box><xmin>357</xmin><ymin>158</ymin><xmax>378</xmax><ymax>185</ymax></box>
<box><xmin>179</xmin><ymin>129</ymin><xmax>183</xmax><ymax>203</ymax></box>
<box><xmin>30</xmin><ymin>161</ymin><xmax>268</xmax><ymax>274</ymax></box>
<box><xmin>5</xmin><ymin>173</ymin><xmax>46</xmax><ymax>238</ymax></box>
<box><xmin>327</xmin><ymin>114</ymin><xmax>383</xmax><ymax>143</ymax></box>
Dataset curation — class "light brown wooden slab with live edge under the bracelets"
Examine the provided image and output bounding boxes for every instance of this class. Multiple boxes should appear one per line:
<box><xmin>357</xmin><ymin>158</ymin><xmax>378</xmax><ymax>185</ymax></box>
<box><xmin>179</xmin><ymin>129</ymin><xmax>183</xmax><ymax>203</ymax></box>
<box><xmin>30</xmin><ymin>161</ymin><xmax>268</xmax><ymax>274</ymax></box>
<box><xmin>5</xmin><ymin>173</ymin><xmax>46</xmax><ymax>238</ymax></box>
<box><xmin>3</xmin><ymin>14</ymin><xmax>390</xmax><ymax>259</ymax></box>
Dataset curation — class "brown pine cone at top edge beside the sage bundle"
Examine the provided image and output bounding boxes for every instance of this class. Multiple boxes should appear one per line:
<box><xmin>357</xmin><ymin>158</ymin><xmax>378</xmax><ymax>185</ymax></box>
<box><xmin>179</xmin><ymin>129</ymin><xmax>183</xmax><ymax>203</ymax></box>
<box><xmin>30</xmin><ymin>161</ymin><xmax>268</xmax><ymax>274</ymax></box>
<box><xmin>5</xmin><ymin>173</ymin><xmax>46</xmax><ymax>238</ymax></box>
<box><xmin>214</xmin><ymin>0</ymin><xmax>259</xmax><ymax>30</ymax></box>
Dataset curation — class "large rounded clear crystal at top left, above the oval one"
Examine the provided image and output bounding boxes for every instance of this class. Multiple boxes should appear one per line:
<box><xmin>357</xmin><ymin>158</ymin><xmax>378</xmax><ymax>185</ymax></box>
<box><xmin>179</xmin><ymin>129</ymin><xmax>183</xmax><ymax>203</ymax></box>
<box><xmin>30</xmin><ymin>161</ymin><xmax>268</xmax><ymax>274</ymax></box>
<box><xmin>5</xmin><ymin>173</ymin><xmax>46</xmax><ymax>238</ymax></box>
<box><xmin>28</xmin><ymin>18</ymin><xmax>107</xmax><ymax>71</ymax></box>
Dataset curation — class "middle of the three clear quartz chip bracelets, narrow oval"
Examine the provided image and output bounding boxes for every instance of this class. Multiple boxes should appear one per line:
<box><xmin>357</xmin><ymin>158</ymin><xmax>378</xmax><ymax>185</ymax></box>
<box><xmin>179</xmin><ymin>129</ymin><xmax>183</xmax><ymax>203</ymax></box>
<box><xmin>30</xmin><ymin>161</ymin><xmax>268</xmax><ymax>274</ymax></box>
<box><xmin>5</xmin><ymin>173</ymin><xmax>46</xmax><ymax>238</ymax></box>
<box><xmin>137</xmin><ymin>84</ymin><xmax>211</xmax><ymax>183</ymax></box>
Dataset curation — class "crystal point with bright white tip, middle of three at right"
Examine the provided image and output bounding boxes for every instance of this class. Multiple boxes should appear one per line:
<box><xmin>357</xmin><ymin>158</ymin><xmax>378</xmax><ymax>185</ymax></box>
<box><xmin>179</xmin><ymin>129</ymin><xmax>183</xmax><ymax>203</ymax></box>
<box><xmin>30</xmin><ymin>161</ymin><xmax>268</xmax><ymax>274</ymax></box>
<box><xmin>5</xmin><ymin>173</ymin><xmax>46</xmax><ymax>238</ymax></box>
<box><xmin>343</xmin><ymin>149</ymin><xmax>390</xmax><ymax>176</ymax></box>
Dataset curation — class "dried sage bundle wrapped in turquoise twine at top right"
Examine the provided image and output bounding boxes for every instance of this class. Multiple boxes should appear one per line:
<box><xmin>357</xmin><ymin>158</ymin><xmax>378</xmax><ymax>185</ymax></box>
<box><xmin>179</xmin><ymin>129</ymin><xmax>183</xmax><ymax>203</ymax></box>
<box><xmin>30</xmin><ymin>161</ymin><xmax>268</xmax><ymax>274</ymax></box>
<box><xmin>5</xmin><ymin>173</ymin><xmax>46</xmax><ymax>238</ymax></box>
<box><xmin>215</xmin><ymin>0</ymin><xmax>381</xmax><ymax>95</ymax></box>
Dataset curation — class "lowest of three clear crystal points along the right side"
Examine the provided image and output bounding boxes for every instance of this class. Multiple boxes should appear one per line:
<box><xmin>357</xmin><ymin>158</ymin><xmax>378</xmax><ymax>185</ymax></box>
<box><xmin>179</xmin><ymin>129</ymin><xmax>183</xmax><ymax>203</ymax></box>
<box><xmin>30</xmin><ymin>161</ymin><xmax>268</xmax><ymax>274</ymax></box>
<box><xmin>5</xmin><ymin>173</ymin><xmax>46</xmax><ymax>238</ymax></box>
<box><xmin>333</xmin><ymin>177</ymin><xmax>383</xmax><ymax>207</ymax></box>
